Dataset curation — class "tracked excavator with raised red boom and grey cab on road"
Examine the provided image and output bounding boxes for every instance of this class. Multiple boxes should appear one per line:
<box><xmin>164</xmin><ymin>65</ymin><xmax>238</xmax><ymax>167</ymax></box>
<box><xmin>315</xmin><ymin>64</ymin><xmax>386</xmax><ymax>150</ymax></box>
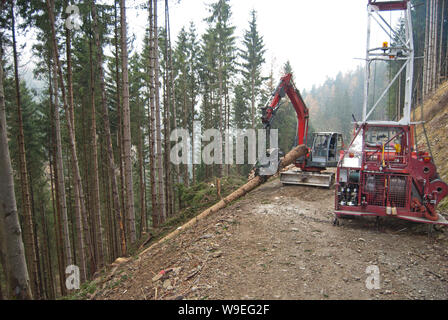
<box><xmin>261</xmin><ymin>73</ymin><xmax>343</xmax><ymax>188</ymax></box>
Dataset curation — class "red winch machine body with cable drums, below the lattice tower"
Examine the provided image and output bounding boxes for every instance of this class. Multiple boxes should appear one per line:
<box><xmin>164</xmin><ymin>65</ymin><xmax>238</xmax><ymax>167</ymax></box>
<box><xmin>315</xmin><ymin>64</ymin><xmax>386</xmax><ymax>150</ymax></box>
<box><xmin>335</xmin><ymin>123</ymin><xmax>448</xmax><ymax>225</ymax></box>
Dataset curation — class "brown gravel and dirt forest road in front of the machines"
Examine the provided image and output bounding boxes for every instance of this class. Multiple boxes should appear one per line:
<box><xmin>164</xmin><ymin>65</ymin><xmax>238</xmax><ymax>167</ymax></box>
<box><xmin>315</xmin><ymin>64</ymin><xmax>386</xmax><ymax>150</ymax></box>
<box><xmin>87</xmin><ymin>179</ymin><xmax>448</xmax><ymax>300</ymax></box>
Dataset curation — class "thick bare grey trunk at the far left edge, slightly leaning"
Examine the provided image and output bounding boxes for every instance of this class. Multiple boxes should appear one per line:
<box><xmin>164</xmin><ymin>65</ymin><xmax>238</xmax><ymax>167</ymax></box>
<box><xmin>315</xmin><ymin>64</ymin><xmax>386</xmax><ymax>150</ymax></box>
<box><xmin>0</xmin><ymin>40</ymin><xmax>32</xmax><ymax>300</ymax></box>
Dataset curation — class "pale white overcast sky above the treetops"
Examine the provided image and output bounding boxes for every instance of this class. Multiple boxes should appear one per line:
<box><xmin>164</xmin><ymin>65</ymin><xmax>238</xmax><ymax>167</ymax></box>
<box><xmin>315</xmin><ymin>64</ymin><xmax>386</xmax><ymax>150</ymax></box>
<box><xmin>127</xmin><ymin>0</ymin><xmax>400</xmax><ymax>89</ymax></box>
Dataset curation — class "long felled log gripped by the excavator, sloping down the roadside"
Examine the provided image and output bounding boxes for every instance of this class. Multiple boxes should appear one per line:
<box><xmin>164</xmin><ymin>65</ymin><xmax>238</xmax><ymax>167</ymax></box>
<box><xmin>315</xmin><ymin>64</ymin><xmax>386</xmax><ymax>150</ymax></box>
<box><xmin>139</xmin><ymin>145</ymin><xmax>308</xmax><ymax>256</ymax></box>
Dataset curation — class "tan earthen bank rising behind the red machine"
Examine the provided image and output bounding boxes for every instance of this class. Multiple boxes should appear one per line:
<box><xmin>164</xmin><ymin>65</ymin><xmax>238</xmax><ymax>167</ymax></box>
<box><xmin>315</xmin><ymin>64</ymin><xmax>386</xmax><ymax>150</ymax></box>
<box><xmin>414</xmin><ymin>81</ymin><xmax>448</xmax><ymax>212</ymax></box>
